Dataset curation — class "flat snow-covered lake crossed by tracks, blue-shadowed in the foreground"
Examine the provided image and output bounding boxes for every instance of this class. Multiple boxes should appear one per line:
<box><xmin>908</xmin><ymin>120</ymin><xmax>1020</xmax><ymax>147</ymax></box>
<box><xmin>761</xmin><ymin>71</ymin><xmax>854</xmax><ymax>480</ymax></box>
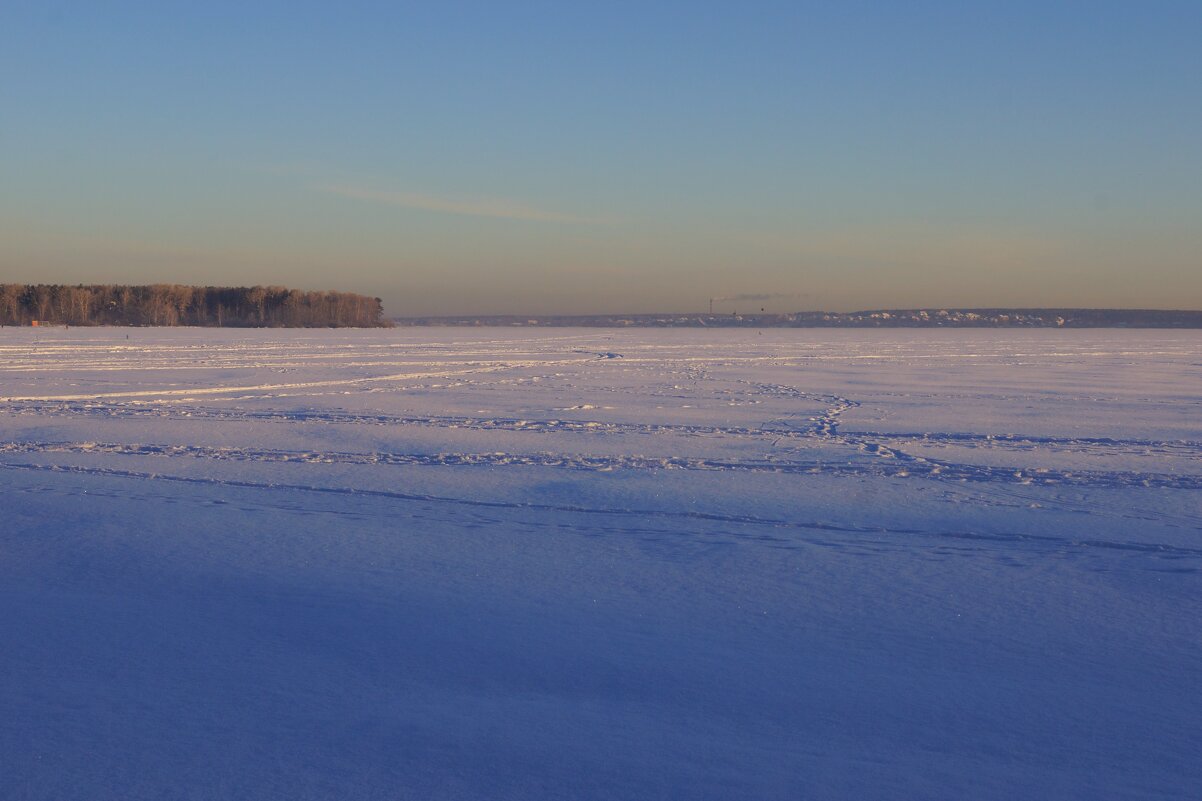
<box><xmin>0</xmin><ymin>328</ymin><xmax>1202</xmax><ymax>801</ymax></box>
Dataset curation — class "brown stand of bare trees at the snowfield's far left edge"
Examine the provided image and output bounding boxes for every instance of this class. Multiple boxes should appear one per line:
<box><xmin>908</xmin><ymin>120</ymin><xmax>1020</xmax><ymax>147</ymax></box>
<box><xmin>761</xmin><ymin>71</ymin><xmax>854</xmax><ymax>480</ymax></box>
<box><xmin>0</xmin><ymin>284</ymin><xmax>389</xmax><ymax>328</ymax></box>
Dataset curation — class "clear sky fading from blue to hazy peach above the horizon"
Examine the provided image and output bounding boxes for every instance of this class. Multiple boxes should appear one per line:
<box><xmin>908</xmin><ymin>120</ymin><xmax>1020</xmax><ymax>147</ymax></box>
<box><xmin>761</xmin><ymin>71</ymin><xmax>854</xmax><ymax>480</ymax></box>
<box><xmin>0</xmin><ymin>0</ymin><xmax>1202</xmax><ymax>315</ymax></box>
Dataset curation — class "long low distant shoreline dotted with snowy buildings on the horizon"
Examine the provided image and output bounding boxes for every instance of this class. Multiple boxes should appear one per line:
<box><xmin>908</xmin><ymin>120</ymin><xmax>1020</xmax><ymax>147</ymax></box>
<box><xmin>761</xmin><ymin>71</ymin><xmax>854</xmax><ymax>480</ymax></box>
<box><xmin>394</xmin><ymin>308</ymin><xmax>1202</xmax><ymax>328</ymax></box>
